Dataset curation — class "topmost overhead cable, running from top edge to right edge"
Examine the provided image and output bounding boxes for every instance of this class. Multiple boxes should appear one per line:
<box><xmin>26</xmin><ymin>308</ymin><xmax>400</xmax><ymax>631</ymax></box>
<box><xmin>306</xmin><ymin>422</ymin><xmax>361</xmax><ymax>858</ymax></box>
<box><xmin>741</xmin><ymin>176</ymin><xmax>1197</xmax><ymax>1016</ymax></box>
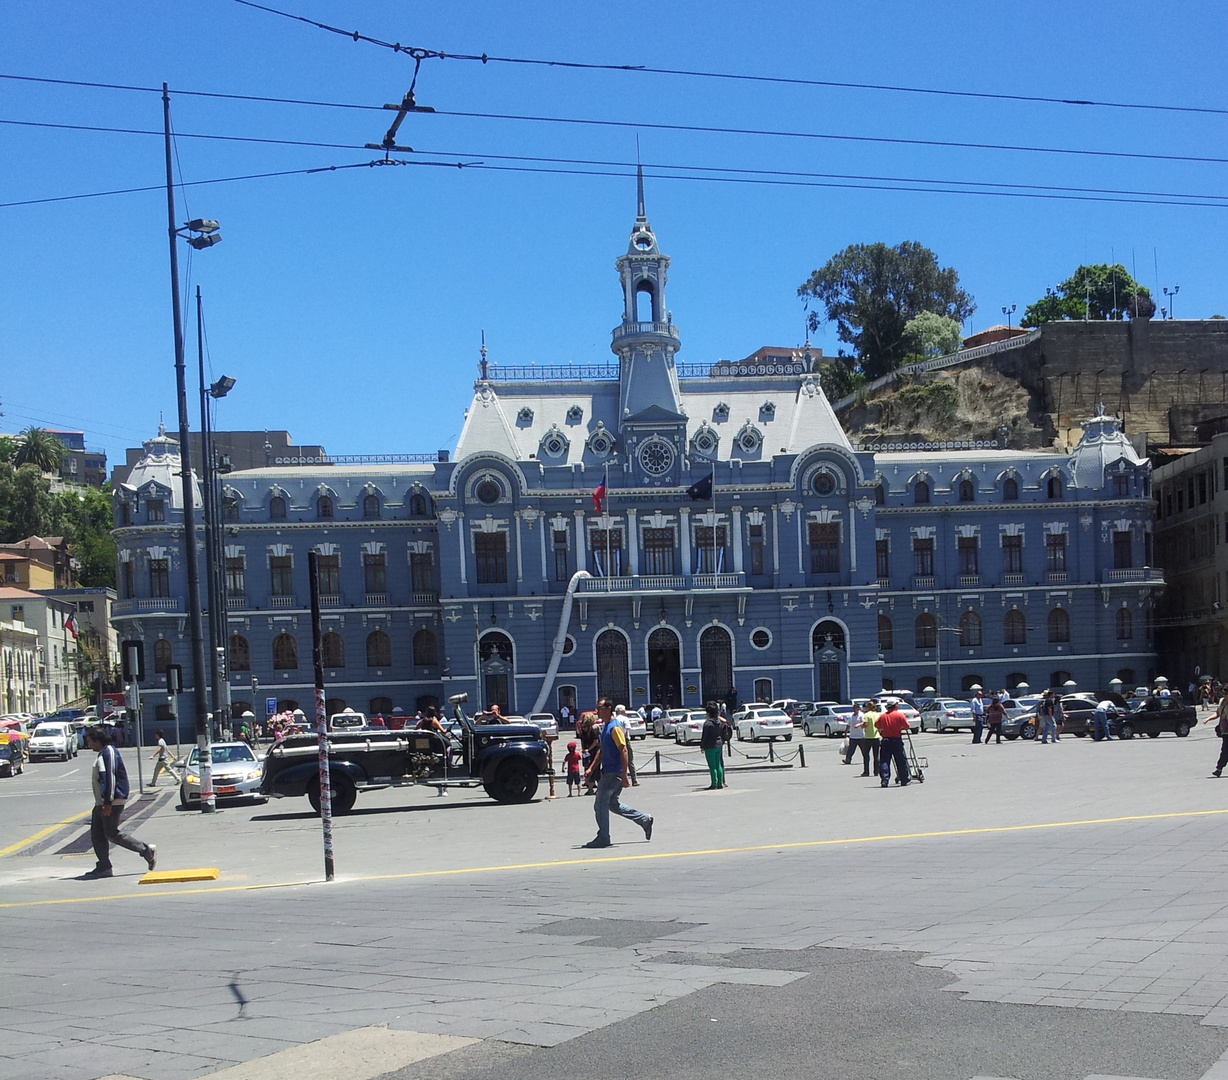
<box><xmin>235</xmin><ymin>0</ymin><xmax>1228</xmax><ymax>115</ymax></box>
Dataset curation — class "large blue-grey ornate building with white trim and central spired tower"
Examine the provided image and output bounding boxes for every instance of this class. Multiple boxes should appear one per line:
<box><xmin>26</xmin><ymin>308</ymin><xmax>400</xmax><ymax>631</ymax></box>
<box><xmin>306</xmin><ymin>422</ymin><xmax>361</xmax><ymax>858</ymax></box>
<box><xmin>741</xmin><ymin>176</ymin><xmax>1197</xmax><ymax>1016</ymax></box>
<box><xmin>115</xmin><ymin>185</ymin><xmax>1163</xmax><ymax>732</ymax></box>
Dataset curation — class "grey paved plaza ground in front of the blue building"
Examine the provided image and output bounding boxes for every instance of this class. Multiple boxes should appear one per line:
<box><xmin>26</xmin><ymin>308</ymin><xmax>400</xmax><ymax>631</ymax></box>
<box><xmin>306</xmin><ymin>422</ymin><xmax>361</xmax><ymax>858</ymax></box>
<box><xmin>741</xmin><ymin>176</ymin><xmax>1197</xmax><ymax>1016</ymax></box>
<box><xmin>7</xmin><ymin>726</ymin><xmax>1228</xmax><ymax>1080</ymax></box>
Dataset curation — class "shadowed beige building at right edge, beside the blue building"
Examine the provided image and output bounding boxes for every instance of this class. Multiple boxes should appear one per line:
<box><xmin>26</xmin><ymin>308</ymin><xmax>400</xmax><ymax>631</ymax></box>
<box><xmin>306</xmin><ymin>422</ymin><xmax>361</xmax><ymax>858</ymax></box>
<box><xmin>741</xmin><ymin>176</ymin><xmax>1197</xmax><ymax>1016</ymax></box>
<box><xmin>1154</xmin><ymin>434</ymin><xmax>1228</xmax><ymax>689</ymax></box>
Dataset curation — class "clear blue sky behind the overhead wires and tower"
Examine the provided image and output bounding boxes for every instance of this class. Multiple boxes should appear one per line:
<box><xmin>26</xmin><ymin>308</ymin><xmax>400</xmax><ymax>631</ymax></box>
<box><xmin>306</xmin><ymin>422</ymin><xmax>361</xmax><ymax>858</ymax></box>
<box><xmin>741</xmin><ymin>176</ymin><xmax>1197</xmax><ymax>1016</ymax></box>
<box><xmin>0</xmin><ymin>0</ymin><xmax>1228</xmax><ymax>460</ymax></box>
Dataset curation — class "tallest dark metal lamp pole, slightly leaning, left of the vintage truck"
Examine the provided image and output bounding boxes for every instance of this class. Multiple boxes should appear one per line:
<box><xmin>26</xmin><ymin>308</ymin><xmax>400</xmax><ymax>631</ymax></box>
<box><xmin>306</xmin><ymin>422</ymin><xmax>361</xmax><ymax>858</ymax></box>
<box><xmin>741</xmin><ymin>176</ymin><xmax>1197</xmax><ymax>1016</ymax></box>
<box><xmin>162</xmin><ymin>82</ymin><xmax>217</xmax><ymax>813</ymax></box>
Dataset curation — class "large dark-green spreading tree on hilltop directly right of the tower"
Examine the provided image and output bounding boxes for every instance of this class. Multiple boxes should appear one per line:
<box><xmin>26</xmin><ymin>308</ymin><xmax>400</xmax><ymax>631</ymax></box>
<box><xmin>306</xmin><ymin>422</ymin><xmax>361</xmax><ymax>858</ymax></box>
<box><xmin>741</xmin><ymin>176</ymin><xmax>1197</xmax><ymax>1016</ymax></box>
<box><xmin>797</xmin><ymin>241</ymin><xmax>976</xmax><ymax>378</ymax></box>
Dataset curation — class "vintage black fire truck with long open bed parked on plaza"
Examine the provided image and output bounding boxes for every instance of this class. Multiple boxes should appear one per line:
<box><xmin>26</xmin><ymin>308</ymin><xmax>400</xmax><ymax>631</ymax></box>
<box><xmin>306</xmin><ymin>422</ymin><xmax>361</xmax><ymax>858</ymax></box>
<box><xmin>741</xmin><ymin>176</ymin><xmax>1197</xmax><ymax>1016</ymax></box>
<box><xmin>260</xmin><ymin>694</ymin><xmax>549</xmax><ymax>813</ymax></box>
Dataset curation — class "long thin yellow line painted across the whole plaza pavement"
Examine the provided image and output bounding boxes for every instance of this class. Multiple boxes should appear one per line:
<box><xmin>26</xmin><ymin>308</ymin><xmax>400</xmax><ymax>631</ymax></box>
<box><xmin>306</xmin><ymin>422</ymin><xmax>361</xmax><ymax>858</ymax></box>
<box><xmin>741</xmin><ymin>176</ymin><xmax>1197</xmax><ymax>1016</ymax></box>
<box><xmin>0</xmin><ymin>810</ymin><xmax>1228</xmax><ymax>910</ymax></box>
